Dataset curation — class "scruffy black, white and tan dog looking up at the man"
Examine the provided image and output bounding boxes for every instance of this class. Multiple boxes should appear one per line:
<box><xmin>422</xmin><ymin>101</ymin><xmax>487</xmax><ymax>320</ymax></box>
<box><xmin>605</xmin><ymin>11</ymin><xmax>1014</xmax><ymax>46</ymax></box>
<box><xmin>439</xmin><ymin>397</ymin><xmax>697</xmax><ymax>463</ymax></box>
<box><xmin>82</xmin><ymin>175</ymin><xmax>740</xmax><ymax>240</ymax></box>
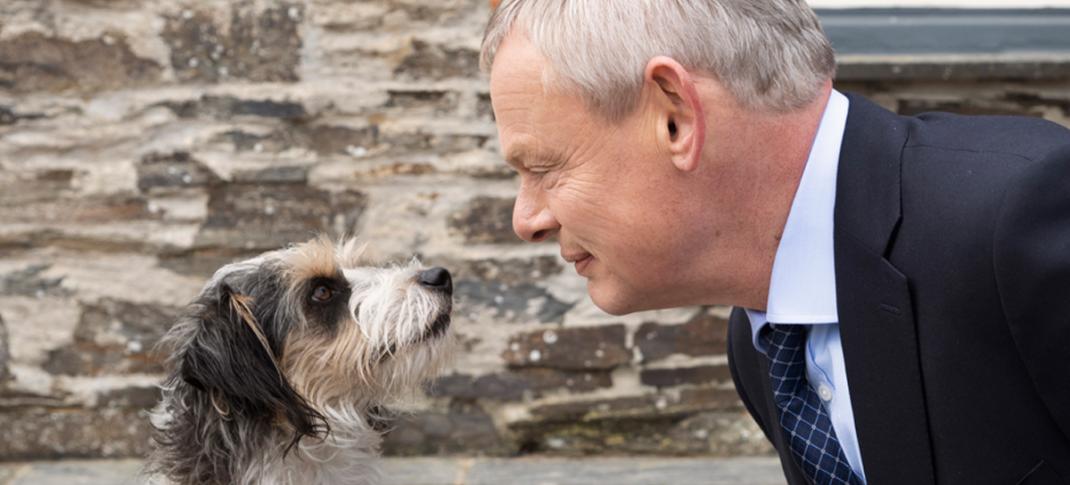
<box><xmin>148</xmin><ymin>238</ymin><xmax>453</xmax><ymax>485</ymax></box>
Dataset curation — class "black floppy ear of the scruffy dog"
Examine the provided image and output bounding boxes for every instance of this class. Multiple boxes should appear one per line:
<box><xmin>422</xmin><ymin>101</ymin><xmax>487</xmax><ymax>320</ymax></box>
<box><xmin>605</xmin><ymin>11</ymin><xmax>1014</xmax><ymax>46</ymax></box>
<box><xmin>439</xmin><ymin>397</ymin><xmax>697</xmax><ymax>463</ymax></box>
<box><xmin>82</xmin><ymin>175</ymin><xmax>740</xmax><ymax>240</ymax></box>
<box><xmin>180</xmin><ymin>282</ymin><xmax>327</xmax><ymax>450</ymax></box>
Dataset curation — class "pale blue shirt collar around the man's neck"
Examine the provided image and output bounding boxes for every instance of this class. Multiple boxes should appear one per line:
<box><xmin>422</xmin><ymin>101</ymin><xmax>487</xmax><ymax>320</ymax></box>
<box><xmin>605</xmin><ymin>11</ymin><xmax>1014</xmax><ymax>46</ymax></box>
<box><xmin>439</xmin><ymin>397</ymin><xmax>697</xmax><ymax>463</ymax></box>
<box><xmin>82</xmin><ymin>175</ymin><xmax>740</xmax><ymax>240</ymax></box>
<box><xmin>747</xmin><ymin>90</ymin><xmax>850</xmax><ymax>338</ymax></box>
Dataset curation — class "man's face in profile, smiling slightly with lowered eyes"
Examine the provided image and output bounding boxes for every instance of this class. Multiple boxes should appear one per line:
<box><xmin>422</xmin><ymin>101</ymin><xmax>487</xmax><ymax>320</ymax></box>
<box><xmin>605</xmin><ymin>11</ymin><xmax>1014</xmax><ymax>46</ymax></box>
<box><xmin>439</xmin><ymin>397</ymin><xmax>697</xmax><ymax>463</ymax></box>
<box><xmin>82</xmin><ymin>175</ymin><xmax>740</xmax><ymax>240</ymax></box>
<box><xmin>490</xmin><ymin>33</ymin><xmax>716</xmax><ymax>314</ymax></box>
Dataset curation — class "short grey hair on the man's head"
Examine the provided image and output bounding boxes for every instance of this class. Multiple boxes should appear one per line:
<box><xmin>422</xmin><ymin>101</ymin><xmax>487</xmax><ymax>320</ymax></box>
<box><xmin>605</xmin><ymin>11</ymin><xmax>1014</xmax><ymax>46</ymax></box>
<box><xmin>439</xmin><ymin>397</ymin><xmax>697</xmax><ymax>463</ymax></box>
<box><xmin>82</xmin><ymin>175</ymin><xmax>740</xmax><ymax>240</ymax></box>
<box><xmin>479</xmin><ymin>0</ymin><xmax>836</xmax><ymax>120</ymax></box>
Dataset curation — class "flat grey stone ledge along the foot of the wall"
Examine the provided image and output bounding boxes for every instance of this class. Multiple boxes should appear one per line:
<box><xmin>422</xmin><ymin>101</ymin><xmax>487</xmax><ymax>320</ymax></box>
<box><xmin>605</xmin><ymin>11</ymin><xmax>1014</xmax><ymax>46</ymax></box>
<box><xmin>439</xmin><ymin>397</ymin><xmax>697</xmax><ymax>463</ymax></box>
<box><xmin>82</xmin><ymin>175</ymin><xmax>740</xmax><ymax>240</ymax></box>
<box><xmin>0</xmin><ymin>457</ymin><xmax>784</xmax><ymax>485</ymax></box>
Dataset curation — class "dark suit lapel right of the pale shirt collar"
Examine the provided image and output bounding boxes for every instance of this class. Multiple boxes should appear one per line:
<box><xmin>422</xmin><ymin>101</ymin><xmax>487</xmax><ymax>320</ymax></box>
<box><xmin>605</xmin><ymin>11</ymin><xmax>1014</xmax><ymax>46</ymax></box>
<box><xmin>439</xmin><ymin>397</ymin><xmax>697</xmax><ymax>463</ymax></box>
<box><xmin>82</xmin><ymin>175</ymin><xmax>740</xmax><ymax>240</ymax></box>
<box><xmin>834</xmin><ymin>96</ymin><xmax>935</xmax><ymax>485</ymax></box>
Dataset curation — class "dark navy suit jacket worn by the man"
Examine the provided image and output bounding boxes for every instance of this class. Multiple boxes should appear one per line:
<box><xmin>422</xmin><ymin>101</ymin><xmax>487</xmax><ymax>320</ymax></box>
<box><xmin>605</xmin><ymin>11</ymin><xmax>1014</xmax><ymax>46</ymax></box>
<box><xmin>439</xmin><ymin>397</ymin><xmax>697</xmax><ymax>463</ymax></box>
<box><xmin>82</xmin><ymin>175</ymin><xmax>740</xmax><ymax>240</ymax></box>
<box><xmin>729</xmin><ymin>95</ymin><xmax>1070</xmax><ymax>485</ymax></box>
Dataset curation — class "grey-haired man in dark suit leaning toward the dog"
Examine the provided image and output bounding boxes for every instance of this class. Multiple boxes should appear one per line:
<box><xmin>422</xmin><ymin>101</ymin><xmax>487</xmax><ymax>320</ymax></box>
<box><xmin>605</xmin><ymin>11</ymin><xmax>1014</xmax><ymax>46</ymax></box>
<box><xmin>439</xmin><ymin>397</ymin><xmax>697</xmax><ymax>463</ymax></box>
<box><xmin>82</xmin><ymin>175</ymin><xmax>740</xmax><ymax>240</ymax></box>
<box><xmin>483</xmin><ymin>0</ymin><xmax>1070</xmax><ymax>485</ymax></box>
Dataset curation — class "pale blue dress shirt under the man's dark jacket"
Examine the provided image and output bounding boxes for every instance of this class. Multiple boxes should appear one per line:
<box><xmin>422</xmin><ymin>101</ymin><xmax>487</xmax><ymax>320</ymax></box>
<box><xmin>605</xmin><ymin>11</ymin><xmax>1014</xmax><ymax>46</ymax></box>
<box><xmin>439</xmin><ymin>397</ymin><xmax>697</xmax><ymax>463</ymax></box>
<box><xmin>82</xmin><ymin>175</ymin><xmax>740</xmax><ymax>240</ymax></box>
<box><xmin>747</xmin><ymin>90</ymin><xmax>866</xmax><ymax>482</ymax></box>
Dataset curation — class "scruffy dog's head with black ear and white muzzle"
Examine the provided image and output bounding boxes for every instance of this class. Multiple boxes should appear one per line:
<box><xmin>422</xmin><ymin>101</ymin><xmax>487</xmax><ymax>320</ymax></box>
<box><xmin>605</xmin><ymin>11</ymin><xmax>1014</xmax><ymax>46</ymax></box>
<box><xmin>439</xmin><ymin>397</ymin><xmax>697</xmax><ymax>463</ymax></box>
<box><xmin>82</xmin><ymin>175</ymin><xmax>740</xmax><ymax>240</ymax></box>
<box><xmin>157</xmin><ymin>239</ymin><xmax>453</xmax><ymax>451</ymax></box>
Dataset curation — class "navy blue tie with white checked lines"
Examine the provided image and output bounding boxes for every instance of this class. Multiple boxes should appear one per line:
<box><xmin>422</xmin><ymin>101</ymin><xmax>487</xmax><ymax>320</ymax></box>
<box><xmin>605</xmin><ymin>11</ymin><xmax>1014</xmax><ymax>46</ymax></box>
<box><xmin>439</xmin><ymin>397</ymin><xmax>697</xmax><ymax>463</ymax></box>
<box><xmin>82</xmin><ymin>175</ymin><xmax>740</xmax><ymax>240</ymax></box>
<box><xmin>762</xmin><ymin>324</ymin><xmax>862</xmax><ymax>485</ymax></box>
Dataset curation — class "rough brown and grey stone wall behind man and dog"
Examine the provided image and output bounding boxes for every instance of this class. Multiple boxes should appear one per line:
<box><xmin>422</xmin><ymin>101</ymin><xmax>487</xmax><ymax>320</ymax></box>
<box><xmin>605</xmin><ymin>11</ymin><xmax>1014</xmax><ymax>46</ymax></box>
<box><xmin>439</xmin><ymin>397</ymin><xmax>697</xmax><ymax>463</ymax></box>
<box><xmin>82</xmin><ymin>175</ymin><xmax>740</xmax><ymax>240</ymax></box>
<box><xmin>0</xmin><ymin>0</ymin><xmax>1070</xmax><ymax>459</ymax></box>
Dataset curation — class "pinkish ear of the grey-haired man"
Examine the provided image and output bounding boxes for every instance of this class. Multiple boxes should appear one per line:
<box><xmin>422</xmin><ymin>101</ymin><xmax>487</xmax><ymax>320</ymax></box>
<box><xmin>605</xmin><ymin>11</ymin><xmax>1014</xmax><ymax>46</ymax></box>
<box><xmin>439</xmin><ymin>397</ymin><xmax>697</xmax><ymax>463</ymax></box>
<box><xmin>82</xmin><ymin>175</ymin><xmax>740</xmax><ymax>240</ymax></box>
<box><xmin>643</xmin><ymin>56</ymin><xmax>706</xmax><ymax>171</ymax></box>
